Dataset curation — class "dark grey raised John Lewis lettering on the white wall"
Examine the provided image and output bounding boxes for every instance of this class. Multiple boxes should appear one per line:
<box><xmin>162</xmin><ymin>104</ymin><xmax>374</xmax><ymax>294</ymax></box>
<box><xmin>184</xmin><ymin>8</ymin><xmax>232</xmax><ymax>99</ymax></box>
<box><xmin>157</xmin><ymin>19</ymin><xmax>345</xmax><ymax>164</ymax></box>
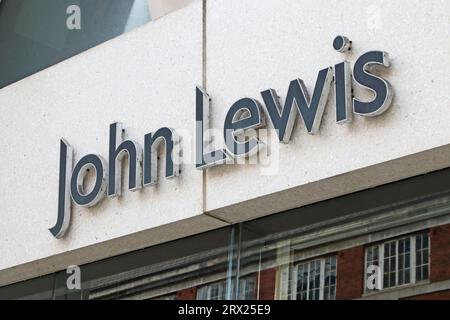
<box><xmin>50</xmin><ymin>36</ymin><xmax>393</xmax><ymax>238</ymax></box>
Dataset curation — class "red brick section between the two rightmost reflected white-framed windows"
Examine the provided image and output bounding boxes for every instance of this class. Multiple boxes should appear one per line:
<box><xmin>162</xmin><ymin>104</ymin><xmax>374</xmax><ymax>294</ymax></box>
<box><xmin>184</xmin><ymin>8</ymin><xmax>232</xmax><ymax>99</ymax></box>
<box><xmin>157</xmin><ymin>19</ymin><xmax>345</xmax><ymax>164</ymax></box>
<box><xmin>336</xmin><ymin>246</ymin><xmax>364</xmax><ymax>300</ymax></box>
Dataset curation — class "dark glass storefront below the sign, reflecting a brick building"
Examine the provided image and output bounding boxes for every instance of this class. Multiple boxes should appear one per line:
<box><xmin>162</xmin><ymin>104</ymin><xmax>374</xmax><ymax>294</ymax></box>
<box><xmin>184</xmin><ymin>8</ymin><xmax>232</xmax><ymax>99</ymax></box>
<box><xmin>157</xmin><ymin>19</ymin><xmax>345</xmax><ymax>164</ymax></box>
<box><xmin>0</xmin><ymin>170</ymin><xmax>450</xmax><ymax>300</ymax></box>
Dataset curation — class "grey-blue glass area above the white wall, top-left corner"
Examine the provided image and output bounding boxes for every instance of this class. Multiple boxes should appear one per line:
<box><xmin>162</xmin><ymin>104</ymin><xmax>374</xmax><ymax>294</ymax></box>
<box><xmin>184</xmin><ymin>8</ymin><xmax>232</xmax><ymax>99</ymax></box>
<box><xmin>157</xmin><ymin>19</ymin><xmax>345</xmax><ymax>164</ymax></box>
<box><xmin>0</xmin><ymin>0</ymin><xmax>150</xmax><ymax>88</ymax></box>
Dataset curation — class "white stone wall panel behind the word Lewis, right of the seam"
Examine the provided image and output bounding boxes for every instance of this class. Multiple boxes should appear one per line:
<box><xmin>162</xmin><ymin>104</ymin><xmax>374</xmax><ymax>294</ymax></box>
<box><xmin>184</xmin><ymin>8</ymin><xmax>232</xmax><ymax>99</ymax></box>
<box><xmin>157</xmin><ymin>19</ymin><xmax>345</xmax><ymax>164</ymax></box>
<box><xmin>206</xmin><ymin>0</ymin><xmax>450</xmax><ymax>222</ymax></box>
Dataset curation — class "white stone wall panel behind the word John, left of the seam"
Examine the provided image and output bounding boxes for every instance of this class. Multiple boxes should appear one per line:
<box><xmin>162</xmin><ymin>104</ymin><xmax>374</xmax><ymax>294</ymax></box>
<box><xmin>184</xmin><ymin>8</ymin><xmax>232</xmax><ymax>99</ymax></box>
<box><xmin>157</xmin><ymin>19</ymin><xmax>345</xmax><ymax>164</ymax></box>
<box><xmin>0</xmin><ymin>2</ymin><xmax>223</xmax><ymax>284</ymax></box>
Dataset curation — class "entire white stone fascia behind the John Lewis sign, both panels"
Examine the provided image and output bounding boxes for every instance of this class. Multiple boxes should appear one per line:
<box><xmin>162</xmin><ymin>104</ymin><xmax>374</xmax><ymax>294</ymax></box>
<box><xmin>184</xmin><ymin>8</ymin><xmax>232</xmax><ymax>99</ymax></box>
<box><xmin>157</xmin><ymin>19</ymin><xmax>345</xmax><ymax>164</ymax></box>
<box><xmin>0</xmin><ymin>0</ymin><xmax>450</xmax><ymax>285</ymax></box>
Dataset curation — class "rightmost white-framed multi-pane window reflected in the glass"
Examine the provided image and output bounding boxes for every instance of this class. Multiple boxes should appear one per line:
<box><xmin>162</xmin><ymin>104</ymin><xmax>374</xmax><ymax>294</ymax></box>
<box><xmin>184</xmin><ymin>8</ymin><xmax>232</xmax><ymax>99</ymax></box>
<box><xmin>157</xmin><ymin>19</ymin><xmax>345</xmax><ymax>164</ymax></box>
<box><xmin>363</xmin><ymin>230</ymin><xmax>431</xmax><ymax>294</ymax></box>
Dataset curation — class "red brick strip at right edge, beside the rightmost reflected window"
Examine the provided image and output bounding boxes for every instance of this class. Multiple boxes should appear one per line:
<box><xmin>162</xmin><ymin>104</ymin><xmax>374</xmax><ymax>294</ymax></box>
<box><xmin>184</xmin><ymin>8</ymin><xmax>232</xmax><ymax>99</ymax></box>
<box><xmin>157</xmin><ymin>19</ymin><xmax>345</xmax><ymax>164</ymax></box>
<box><xmin>430</xmin><ymin>224</ymin><xmax>450</xmax><ymax>282</ymax></box>
